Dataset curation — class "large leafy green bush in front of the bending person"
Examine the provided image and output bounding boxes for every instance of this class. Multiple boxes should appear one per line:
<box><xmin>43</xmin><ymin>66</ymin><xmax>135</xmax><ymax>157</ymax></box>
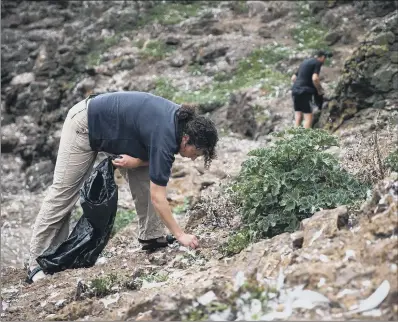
<box><xmin>231</xmin><ymin>128</ymin><xmax>368</xmax><ymax>237</ymax></box>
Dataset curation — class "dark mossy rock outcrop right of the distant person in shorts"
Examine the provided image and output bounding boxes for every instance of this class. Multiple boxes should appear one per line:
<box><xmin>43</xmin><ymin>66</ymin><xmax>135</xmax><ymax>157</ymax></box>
<box><xmin>316</xmin><ymin>13</ymin><xmax>398</xmax><ymax>131</ymax></box>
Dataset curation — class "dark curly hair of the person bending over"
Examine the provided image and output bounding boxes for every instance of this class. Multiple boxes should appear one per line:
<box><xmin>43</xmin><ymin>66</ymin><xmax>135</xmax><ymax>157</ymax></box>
<box><xmin>177</xmin><ymin>104</ymin><xmax>218</xmax><ymax>169</ymax></box>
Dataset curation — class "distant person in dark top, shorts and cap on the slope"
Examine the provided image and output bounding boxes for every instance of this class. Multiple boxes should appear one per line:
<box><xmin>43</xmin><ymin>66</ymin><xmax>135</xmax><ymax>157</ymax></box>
<box><xmin>292</xmin><ymin>50</ymin><xmax>332</xmax><ymax>128</ymax></box>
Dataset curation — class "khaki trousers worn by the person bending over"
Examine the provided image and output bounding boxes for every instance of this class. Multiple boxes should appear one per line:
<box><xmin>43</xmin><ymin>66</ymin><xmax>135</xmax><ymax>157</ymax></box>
<box><xmin>29</xmin><ymin>100</ymin><xmax>164</xmax><ymax>268</ymax></box>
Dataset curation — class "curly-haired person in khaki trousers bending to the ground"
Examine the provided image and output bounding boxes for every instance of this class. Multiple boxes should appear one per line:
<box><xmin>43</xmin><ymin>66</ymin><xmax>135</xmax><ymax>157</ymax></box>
<box><xmin>27</xmin><ymin>92</ymin><xmax>218</xmax><ymax>282</ymax></box>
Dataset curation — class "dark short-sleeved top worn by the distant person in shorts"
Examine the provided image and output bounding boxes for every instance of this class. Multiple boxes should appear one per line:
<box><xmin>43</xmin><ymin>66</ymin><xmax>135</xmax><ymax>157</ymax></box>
<box><xmin>292</xmin><ymin>58</ymin><xmax>322</xmax><ymax>95</ymax></box>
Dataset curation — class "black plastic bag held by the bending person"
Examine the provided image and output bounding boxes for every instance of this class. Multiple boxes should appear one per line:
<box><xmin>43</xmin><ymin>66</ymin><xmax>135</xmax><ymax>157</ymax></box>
<box><xmin>36</xmin><ymin>157</ymin><xmax>118</xmax><ymax>274</ymax></box>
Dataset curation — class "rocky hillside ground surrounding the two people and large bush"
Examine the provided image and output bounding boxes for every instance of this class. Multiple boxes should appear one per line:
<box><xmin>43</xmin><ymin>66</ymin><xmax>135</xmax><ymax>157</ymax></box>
<box><xmin>1</xmin><ymin>1</ymin><xmax>398</xmax><ymax>320</ymax></box>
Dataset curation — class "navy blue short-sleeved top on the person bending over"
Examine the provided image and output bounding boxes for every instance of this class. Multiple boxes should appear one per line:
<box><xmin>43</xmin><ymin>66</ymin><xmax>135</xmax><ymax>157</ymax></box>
<box><xmin>88</xmin><ymin>92</ymin><xmax>180</xmax><ymax>186</ymax></box>
